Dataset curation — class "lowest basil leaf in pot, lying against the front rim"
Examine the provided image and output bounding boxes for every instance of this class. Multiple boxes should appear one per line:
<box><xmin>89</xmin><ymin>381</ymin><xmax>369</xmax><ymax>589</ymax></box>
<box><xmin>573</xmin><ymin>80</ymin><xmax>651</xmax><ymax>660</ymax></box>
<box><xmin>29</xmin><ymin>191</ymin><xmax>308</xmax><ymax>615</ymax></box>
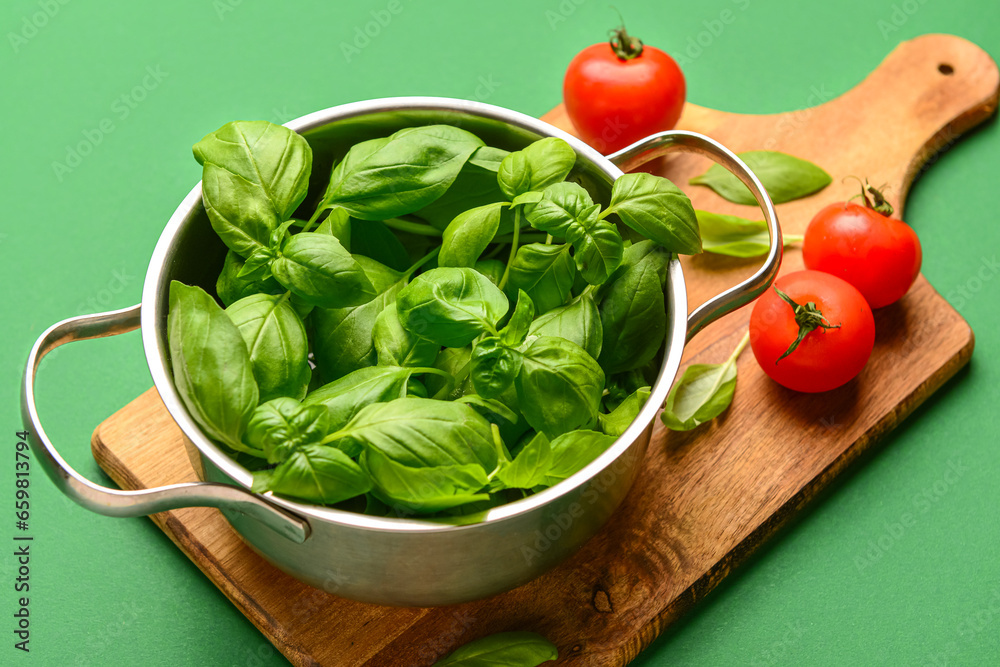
<box><xmin>361</xmin><ymin>448</ymin><xmax>490</xmax><ymax>514</ymax></box>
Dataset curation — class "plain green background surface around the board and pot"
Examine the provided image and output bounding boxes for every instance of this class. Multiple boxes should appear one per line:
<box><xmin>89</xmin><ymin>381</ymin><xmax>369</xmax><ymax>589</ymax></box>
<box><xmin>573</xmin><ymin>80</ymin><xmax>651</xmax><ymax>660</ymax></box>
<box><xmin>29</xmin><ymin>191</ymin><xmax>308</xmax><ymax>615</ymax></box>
<box><xmin>0</xmin><ymin>0</ymin><xmax>1000</xmax><ymax>666</ymax></box>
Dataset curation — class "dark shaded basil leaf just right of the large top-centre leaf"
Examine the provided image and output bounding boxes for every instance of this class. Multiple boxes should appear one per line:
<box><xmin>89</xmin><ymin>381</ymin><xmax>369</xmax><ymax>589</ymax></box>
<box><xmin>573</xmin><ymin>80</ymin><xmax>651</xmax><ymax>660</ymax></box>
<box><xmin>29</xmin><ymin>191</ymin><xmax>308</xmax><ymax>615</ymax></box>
<box><xmin>415</xmin><ymin>146</ymin><xmax>509</xmax><ymax>231</ymax></box>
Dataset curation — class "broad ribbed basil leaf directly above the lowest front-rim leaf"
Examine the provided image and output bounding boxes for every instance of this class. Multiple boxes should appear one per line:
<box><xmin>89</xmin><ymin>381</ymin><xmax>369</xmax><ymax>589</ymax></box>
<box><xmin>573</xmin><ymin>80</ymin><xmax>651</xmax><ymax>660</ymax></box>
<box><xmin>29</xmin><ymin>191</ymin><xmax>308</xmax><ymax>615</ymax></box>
<box><xmin>340</xmin><ymin>398</ymin><xmax>497</xmax><ymax>472</ymax></box>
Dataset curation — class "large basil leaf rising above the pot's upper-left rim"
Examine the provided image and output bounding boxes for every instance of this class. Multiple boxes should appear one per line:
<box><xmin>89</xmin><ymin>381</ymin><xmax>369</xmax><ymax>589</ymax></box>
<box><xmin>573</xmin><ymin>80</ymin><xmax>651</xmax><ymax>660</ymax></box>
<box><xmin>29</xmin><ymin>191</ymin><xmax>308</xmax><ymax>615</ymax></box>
<box><xmin>193</xmin><ymin>121</ymin><xmax>312</xmax><ymax>257</ymax></box>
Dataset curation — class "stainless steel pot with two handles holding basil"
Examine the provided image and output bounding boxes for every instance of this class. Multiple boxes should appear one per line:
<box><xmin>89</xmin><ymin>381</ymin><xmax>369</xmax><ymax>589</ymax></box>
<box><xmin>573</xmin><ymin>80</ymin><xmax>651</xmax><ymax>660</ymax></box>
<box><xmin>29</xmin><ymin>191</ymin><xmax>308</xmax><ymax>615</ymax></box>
<box><xmin>21</xmin><ymin>97</ymin><xmax>782</xmax><ymax>606</ymax></box>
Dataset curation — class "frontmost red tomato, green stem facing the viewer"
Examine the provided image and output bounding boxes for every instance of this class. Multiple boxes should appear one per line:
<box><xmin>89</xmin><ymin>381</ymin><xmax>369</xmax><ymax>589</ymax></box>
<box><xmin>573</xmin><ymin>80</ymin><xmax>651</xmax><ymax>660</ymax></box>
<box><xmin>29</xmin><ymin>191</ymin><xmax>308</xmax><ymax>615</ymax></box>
<box><xmin>750</xmin><ymin>271</ymin><xmax>875</xmax><ymax>392</ymax></box>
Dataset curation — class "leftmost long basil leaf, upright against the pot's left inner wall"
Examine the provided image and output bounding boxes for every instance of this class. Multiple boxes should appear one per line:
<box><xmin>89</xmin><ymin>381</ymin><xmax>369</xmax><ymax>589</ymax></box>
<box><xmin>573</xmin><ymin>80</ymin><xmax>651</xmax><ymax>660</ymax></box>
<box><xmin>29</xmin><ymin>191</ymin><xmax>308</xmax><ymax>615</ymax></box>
<box><xmin>167</xmin><ymin>280</ymin><xmax>259</xmax><ymax>451</ymax></box>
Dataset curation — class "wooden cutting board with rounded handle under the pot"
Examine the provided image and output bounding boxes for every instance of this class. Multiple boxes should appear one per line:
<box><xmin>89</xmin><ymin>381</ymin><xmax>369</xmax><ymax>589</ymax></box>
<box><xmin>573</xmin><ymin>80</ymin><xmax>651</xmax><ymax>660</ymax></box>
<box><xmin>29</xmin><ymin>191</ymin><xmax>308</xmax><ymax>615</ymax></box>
<box><xmin>93</xmin><ymin>35</ymin><xmax>1000</xmax><ymax>667</ymax></box>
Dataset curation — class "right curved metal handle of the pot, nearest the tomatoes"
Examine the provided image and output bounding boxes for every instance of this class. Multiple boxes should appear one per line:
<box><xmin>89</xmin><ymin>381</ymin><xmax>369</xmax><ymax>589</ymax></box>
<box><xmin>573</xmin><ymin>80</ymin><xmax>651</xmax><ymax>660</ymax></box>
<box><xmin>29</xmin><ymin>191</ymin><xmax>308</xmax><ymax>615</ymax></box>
<box><xmin>608</xmin><ymin>130</ymin><xmax>783</xmax><ymax>340</ymax></box>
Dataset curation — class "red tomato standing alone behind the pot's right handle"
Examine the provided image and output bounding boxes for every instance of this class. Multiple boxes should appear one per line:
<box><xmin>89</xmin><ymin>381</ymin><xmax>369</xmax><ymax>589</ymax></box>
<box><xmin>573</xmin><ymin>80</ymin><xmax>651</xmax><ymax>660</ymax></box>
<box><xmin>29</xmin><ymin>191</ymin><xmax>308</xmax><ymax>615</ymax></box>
<box><xmin>563</xmin><ymin>26</ymin><xmax>686</xmax><ymax>154</ymax></box>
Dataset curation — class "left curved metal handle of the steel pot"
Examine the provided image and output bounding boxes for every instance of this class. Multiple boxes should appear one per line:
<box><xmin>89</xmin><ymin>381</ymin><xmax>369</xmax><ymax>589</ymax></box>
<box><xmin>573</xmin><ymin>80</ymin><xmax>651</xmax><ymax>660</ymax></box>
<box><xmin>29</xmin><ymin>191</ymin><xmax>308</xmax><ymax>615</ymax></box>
<box><xmin>21</xmin><ymin>304</ymin><xmax>309</xmax><ymax>543</ymax></box>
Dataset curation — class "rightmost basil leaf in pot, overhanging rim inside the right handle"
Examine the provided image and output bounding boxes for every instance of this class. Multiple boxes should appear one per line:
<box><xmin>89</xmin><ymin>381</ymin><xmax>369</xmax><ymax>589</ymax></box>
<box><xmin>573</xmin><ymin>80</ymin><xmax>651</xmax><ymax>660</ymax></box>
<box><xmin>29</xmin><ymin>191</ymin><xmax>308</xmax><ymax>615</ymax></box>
<box><xmin>601</xmin><ymin>172</ymin><xmax>701</xmax><ymax>255</ymax></box>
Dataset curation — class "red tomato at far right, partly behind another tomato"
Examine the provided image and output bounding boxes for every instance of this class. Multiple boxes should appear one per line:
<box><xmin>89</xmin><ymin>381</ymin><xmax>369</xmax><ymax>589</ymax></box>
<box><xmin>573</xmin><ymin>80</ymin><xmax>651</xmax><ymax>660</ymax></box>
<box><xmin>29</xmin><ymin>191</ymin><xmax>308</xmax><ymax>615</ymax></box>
<box><xmin>802</xmin><ymin>188</ymin><xmax>923</xmax><ymax>308</ymax></box>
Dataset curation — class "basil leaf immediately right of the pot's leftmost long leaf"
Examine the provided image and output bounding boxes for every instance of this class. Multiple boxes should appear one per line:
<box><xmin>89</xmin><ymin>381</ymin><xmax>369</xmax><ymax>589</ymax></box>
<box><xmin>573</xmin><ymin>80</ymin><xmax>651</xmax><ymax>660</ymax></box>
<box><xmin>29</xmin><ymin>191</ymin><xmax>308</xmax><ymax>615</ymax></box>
<box><xmin>226</xmin><ymin>294</ymin><xmax>312</xmax><ymax>403</ymax></box>
